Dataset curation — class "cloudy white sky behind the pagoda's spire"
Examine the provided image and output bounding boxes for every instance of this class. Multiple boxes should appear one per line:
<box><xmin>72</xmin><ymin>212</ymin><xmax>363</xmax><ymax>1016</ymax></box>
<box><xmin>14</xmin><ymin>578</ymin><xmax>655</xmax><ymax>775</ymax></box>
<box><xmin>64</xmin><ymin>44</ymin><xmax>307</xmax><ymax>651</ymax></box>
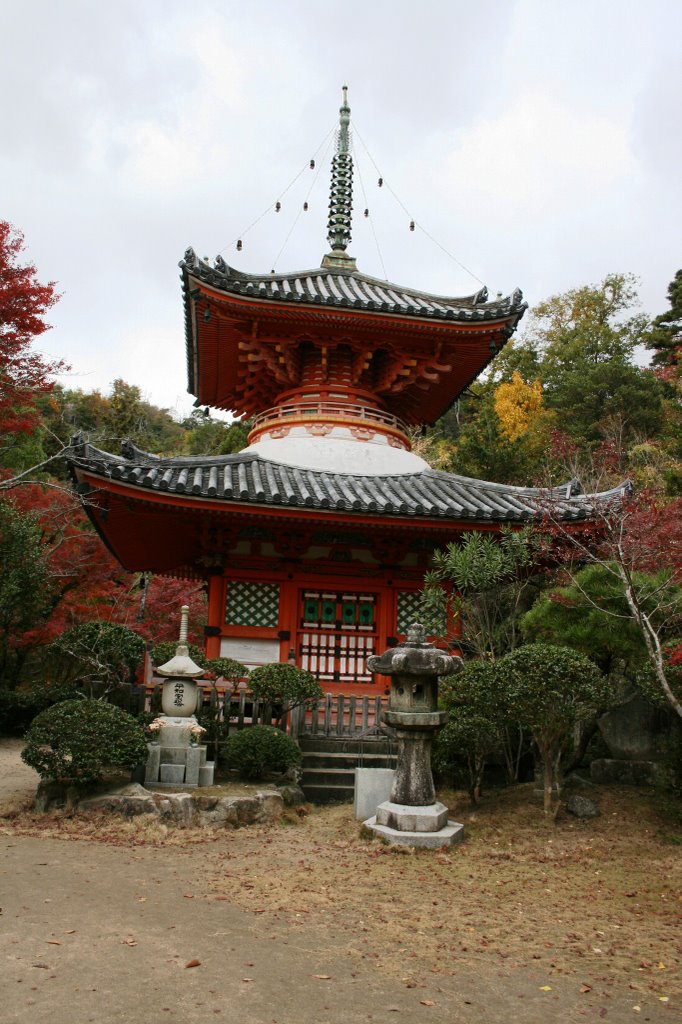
<box><xmin>0</xmin><ymin>0</ymin><xmax>682</xmax><ymax>413</ymax></box>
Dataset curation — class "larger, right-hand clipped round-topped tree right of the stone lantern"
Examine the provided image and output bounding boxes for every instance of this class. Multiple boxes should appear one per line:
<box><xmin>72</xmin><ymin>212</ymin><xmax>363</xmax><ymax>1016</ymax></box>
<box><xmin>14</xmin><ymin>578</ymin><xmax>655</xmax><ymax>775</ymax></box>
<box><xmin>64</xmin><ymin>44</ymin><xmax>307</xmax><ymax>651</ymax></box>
<box><xmin>499</xmin><ymin>643</ymin><xmax>608</xmax><ymax>814</ymax></box>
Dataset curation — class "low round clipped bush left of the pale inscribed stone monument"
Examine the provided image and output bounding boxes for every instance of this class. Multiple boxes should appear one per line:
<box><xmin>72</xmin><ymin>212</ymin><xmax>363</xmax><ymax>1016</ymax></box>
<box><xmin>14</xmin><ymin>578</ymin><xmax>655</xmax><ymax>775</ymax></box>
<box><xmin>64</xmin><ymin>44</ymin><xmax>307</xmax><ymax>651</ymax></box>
<box><xmin>22</xmin><ymin>699</ymin><xmax>147</xmax><ymax>785</ymax></box>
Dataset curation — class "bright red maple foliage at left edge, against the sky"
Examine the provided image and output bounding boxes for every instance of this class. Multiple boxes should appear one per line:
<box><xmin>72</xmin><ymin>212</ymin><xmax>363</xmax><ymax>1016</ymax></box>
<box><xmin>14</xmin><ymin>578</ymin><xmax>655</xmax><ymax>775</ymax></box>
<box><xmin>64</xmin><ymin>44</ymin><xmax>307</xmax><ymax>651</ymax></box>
<box><xmin>0</xmin><ymin>220</ymin><xmax>66</xmax><ymax>434</ymax></box>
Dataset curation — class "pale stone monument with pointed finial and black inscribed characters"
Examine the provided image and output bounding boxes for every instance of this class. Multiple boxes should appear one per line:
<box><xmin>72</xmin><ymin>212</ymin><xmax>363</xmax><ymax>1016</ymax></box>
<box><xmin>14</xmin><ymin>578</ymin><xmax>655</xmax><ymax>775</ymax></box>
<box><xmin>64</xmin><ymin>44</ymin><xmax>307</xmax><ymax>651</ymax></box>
<box><xmin>144</xmin><ymin>604</ymin><xmax>215</xmax><ymax>790</ymax></box>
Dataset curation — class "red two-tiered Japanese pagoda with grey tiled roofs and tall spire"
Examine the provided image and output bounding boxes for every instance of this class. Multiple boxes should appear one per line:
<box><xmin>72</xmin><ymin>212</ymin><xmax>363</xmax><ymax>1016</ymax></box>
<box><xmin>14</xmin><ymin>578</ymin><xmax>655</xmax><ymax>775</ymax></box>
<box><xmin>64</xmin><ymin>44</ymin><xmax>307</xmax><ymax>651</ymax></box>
<box><xmin>70</xmin><ymin>88</ymin><xmax>622</xmax><ymax>694</ymax></box>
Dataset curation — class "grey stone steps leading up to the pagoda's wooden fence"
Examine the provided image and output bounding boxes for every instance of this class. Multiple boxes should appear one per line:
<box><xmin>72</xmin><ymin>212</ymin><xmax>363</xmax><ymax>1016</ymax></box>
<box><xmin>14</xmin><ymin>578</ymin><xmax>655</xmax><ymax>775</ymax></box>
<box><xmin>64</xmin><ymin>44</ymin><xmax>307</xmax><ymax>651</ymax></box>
<box><xmin>298</xmin><ymin>736</ymin><xmax>397</xmax><ymax>804</ymax></box>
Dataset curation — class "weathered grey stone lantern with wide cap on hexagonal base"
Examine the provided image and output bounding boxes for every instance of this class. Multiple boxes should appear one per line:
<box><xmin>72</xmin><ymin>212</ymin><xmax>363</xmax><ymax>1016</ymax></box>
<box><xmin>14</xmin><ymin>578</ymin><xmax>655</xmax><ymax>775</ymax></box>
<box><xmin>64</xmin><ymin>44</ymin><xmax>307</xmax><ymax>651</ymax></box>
<box><xmin>365</xmin><ymin>623</ymin><xmax>464</xmax><ymax>848</ymax></box>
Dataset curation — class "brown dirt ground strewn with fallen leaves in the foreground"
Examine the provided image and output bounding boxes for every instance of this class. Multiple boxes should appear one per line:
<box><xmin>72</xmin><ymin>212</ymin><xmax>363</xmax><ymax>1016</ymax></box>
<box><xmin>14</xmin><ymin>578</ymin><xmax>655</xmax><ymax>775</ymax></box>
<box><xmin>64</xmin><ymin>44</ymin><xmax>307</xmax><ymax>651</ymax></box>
<box><xmin>0</xmin><ymin>740</ymin><xmax>682</xmax><ymax>1024</ymax></box>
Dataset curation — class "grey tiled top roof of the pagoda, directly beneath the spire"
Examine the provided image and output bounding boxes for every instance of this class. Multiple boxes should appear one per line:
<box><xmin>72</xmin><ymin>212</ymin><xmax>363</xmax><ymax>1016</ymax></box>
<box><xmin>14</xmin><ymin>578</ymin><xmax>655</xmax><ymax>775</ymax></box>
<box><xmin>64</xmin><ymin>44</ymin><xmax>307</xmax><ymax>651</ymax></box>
<box><xmin>179</xmin><ymin>249</ymin><xmax>527</xmax><ymax>330</ymax></box>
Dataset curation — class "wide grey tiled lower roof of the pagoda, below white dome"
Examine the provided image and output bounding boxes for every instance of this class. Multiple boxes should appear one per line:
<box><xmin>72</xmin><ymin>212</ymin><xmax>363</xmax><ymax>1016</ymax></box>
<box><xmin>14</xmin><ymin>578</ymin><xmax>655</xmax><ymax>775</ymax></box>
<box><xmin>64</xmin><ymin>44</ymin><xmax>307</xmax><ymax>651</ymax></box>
<box><xmin>69</xmin><ymin>438</ymin><xmax>627</xmax><ymax>523</ymax></box>
